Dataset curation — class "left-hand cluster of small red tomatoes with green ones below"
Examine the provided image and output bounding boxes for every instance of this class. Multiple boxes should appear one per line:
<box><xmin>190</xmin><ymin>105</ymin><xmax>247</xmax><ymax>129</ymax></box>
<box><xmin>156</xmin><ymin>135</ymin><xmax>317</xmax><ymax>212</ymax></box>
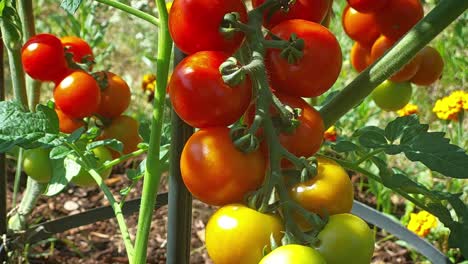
<box><xmin>21</xmin><ymin>34</ymin><xmax>141</xmax><ymax>186</ymax></box>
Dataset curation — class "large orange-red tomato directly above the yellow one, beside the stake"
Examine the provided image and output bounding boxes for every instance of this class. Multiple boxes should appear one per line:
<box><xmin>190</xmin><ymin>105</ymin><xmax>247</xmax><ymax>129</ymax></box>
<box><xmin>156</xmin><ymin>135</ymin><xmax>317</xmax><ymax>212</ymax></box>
<box><xmin>180</xmin><ymin>127</ymin><xmax>266</xmax><ymax>205</ymax></box>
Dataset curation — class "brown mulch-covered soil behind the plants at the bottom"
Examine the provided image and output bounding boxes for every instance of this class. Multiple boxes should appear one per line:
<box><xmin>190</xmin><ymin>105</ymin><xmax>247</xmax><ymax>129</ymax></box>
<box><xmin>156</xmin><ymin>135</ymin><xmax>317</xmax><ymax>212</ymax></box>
<box><xmin>8</xmin><ymin>160</ymin><xmax>414</xmax><ymax>264</ymax></box>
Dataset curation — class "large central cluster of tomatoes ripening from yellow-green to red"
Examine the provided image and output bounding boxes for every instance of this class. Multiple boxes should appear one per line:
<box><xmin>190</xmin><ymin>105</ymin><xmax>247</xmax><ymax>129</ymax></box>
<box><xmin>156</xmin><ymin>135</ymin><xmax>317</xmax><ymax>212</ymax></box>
<box><xmin>168</xmin><ymin>0</ymin><xmax>374</xmax><ymax>264</ymax></box>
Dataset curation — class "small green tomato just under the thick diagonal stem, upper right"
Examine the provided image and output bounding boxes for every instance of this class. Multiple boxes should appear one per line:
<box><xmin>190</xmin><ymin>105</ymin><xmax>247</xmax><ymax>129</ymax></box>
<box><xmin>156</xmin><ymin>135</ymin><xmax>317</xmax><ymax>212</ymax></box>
<box><xmin>371</xmin><ymin>80</ymin><xmax>412</xmax><ymax>111</ymax></box>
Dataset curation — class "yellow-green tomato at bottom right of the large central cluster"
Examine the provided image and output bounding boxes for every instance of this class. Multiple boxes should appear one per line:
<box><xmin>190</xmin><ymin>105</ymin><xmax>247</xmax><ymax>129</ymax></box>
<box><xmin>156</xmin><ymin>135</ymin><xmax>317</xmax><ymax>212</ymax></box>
<box><xmin>317</xmin><ymin>214</ymin><xmax>374</xmax><ymax>264</ymax></box>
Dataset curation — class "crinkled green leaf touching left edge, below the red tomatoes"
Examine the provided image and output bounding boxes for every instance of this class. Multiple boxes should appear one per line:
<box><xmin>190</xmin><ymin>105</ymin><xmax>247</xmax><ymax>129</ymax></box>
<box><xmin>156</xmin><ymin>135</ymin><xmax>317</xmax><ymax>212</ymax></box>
<box><xmin>0</xmin><ymin>101</ymin><xmax>64</xmax><ymax>153</ymax></box>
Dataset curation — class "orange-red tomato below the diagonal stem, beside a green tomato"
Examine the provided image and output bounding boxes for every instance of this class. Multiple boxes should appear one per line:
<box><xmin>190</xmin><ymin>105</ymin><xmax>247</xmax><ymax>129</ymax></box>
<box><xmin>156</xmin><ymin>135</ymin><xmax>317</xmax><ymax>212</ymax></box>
<box><xmin>411</xmin><ymin>46</ymin><xmax>444</xmax><ymax>85</ymax></box>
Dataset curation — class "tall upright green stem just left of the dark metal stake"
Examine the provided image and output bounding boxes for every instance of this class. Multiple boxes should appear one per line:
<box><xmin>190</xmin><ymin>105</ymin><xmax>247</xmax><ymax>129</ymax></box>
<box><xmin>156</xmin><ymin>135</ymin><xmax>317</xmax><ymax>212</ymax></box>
<box><xmin>135</xmin><ymin>0</ymin><xmax>172</xmax><ymax>264</ymax></box>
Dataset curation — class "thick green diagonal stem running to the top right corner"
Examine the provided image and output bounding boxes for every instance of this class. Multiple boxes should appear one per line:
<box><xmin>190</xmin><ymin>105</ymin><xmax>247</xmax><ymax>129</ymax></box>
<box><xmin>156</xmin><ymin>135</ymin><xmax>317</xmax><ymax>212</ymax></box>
<box><xmin>320</xmin><ymin>0</ymin><xmax>468</xmax><ymax>128</ymax></box>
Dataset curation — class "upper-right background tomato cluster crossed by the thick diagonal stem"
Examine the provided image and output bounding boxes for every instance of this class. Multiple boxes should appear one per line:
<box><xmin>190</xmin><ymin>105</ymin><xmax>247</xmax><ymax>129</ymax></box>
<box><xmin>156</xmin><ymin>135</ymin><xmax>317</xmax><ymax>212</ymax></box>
<box><xmin>342</xmin><ymin>0</ymin><xmax>444</xmax><ymax>111</ymax></box>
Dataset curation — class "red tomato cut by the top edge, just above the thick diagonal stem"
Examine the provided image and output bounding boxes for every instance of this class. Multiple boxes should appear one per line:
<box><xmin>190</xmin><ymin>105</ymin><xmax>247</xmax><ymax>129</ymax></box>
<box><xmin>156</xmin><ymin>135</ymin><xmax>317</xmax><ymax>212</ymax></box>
<box><xmin>374</xmin><ymin>0</ymin><xmax>424</xmax><ymax>40</ymax></box>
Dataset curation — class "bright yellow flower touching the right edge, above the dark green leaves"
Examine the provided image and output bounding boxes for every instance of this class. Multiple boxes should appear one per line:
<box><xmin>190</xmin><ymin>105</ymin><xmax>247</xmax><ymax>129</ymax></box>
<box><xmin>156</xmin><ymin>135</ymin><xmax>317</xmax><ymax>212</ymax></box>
<box><xmin>432</xmin><ymin>90</ymin><xmax>468</xmax><ymax>121</ymax></box>
